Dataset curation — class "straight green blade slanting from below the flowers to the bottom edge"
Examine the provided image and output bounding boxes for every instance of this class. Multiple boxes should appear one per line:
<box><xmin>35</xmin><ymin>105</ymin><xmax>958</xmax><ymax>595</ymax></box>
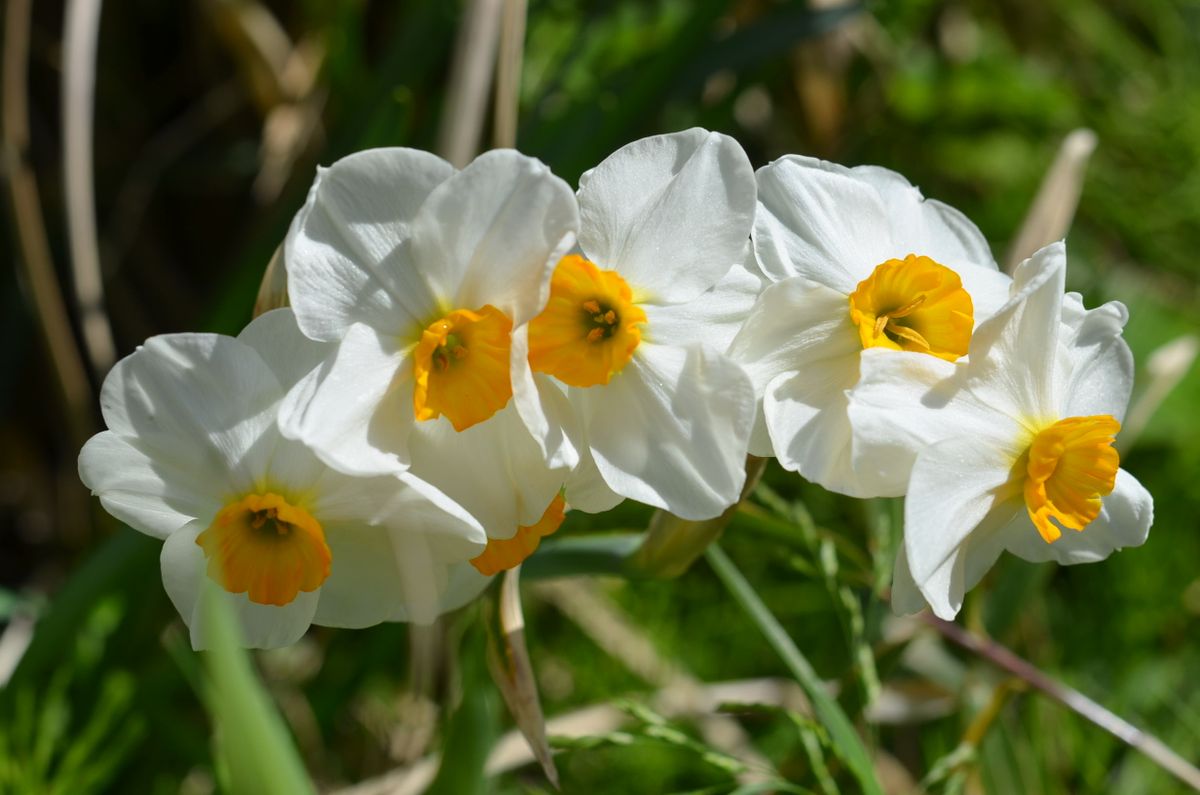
<box><xmin>704</xmin><ymin>544</ymin><xmax>883</xmax><ymax>795</ymax></box>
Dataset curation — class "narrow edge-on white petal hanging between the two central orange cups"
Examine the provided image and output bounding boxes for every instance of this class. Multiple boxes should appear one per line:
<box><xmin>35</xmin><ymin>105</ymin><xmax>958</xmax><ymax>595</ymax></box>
<box><xmin>511</xmin><ymin>325</ymin><xmax>580</xmax><ymax>470</ymax></box>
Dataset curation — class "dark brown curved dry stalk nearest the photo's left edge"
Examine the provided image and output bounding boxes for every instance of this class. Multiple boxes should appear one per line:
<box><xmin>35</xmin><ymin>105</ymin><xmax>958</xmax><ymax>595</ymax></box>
<box><xmin>2</xmin><ymin>0</ymin><xmax>92</xmax><ymax>444</ymax></box>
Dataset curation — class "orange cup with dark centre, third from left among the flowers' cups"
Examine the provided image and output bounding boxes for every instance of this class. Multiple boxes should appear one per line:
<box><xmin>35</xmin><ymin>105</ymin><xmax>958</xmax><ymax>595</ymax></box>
<box><xmin>529</xmin><ymin>255</ymin><xmax>646</xmax><ymax>387</ymax></box>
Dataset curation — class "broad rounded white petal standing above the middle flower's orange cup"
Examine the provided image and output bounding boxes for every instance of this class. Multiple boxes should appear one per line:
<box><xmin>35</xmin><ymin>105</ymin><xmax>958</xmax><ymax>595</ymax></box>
<box><xmin>578</xmin><ymin>128</ymin><xmax>755</xmax><ymax>304</ymax></box>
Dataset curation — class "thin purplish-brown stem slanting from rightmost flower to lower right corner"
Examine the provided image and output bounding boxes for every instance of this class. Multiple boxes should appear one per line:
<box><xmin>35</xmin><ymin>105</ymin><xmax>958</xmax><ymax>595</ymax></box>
<box><xmin>920</xmin><ymin>612</ymin><xmax>1200</xmax><ymax>791</ymax></box>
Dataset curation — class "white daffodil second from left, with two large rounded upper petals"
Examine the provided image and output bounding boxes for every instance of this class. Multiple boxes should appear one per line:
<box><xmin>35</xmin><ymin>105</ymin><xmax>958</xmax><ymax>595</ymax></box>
<box><xmin>280</xmin><ymin>149</ymin><xmax>578</xmax><ymax>476</ymax></box>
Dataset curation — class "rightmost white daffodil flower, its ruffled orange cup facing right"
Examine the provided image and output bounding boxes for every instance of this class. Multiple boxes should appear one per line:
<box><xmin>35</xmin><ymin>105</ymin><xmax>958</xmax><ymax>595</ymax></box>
<box><xmin>850</xmin><ymin>243</ymin><xmax>1153</xmax><ymax>618</ymax></box>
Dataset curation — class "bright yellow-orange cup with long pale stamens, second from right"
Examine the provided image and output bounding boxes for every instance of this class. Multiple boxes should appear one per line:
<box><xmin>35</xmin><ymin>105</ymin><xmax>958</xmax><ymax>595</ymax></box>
<box><xmin>850</xmin><ymin>255</ymin><xmax>974</xmax><ymax>361</ymax></box>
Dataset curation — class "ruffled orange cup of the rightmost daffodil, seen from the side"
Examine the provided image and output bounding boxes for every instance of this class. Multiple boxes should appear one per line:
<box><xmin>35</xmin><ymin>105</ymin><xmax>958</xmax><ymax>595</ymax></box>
<box><xmin>1025</xmin><ymin>414</ymin><xmax>1121</xmax><ymax>544</ymax></box>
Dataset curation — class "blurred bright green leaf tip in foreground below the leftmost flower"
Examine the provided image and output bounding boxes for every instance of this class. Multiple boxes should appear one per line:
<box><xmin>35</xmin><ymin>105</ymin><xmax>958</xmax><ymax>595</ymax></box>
<box><xmin>200</xmin><ymin>580</ymin><xmax>316</xmax><ymax>795</ymax></box>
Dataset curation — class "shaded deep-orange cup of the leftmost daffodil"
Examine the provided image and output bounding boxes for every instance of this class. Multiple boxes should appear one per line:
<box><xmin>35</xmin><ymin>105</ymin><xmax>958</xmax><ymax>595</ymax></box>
<box><xmin>196</xmin><ymin>491</ymin><xmax>332</xmax><ymax>606</ymax></box>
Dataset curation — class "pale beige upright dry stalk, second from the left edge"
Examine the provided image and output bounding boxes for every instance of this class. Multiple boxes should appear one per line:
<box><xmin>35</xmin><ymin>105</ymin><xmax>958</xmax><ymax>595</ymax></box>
<box><xmin>62</xmin><ymin>0</ymin><xmax>116</xmax><ymax>378</ymax></box>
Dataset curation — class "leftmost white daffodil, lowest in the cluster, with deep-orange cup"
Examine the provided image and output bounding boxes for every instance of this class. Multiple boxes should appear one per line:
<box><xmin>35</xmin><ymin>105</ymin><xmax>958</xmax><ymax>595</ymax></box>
<box><xmin>79</xmin><ymin>310</ymin><xmax>487</xmax><ymax>648</ymax></box>
